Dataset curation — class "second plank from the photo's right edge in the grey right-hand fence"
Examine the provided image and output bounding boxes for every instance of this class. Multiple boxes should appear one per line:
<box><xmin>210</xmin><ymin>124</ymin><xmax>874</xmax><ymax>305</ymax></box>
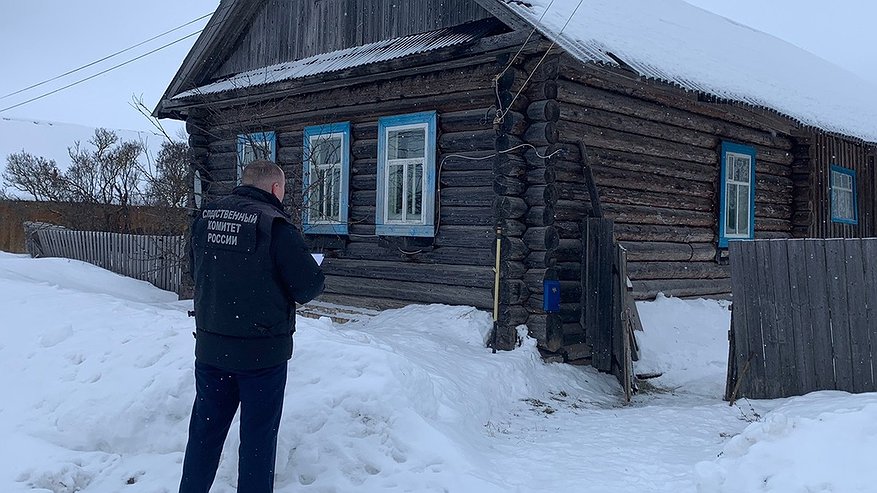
<box><xmin>833</xmin><ymin>239</ymin><xmax>874</xmax><ymax>392</ymax></box>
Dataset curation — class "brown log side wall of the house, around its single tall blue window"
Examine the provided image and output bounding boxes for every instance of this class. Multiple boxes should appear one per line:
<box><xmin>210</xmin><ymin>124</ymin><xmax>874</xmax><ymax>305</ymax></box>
<box><xmin>557</xmin><ymin>56</ymin><xmax>794</xmax><ymax>299</ymax></box>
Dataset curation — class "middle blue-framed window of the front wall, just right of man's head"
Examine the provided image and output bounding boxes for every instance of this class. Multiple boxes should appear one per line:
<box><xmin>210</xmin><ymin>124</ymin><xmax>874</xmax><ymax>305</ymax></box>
<box><xmin>302</xmin><ymin>122</ymin><xmax>350</xmax><ymax>235</ymax></box>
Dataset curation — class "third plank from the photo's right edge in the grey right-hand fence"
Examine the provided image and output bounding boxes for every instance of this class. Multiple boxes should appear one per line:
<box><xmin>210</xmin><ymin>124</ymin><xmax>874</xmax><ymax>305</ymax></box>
<box><xmin>825</xmin><ymin>240</ymin><xmax>854</xmax><ymax>392</ymax></box>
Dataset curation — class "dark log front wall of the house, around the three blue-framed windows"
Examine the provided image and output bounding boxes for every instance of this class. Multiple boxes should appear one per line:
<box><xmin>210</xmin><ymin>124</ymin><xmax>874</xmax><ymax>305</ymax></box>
<box><xmin>195</xmin><ymin>62</ymin><xmax>504</xmax><ymax>312</ymax></box>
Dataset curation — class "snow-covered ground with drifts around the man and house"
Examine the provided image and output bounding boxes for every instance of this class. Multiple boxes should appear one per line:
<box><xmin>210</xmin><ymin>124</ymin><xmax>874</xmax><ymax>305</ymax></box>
<box><xmin>0</xmin><ymin>253</ymin><xmax>877</xmax><ymax>493</ymax></box>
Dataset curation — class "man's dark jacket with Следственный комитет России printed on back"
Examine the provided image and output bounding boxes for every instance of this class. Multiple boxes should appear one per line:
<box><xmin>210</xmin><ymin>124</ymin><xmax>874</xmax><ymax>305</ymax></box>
<box><xmin>190</xmin><ymin>186</ymin><xmax>324</xmax><ymax>370</ymax></box>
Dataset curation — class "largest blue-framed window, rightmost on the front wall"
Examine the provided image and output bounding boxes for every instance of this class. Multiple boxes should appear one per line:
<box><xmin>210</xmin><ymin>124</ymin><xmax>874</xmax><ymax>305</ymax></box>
<box><xmin>375</xmin><ymin>111</ymin><xmax>436</xmax><ymax>236</ymax></box>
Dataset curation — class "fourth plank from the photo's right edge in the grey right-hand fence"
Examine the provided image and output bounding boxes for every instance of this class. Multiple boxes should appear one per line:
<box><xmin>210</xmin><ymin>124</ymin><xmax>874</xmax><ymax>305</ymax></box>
<box><xmin>804</xmin><ymin>240</ymin><xmax>836</xmax><ymax>390</ymax></box>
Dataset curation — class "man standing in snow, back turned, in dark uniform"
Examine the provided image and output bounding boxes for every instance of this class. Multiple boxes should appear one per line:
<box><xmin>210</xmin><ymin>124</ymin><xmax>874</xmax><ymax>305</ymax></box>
<box><xmin>180</xmin><ymin>160</ymin><xmax>324</xmax><ymax>493</ymax></box>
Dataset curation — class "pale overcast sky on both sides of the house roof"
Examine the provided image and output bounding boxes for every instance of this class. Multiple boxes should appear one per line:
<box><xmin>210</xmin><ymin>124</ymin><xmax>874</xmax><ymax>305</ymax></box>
<box><xmin>0</xmin><ymin>0</ymin><xmax>877</xmax><ymax>134</ymax></box>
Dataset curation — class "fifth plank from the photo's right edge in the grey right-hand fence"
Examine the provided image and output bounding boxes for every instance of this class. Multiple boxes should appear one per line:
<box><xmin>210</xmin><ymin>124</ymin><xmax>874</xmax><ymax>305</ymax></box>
<box><xmin>786</xmin><ymin>240</ymin><xmax>816</xmax><ymax>395</ymax></box>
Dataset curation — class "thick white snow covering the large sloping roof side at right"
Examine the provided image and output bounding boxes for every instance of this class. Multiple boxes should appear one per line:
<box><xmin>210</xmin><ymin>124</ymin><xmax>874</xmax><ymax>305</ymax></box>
<box><xmin>503</xmin><ymin>0</ymin><xmax>877</xmax><ymax>142</ymax></box>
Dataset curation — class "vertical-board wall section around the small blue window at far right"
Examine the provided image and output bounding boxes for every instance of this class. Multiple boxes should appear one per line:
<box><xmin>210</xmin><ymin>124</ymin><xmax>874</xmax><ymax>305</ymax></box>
<box><xmin>795</xmin><ymin>132</ymin><xmax>877</xmax><ymax>238</ymax></box>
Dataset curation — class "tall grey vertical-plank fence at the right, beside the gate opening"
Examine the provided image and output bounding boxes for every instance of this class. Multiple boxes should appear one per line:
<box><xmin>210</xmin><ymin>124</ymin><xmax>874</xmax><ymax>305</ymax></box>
<box><xmin>725</xmin><ymin>238</ymin><xmax>877</xmax><ymax>401</ymax></box>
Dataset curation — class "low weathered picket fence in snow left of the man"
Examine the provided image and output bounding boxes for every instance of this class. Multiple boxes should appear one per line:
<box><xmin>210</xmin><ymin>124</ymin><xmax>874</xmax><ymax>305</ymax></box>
<box><xmin>28</xmin><ymin>228</ymin><xmax>185</xmax><ymax>293</ymax></box>
